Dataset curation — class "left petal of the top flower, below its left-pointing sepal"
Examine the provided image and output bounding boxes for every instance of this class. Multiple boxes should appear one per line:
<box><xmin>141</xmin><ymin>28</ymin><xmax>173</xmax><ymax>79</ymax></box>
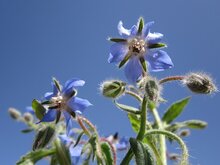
<box><xmin>108</xmin><ymin>43</ymin><xmax>128</xmax><ymax>63</ymax></box>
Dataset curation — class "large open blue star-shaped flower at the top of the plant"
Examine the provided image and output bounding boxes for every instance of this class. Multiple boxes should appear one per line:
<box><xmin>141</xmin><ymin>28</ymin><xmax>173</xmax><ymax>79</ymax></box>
<box><xmin>108</xmin><ymin>18</ymin><xmax>173</xmax><ymax>83</ymax></box>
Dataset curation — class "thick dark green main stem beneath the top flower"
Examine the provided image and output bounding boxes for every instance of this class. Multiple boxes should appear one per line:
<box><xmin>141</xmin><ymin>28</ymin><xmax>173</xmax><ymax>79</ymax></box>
<box><xmin>121</xmin><ymin>97</ymin><xmax>147</xmax><ymax>165</ymax></box>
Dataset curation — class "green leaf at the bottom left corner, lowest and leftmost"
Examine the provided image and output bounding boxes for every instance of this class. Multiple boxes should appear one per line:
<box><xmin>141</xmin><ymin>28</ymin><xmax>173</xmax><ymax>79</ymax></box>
<box><xmin>16</xmin><ymin>148</ymin><xmax>55</xmax><ymax>165</ymax></box>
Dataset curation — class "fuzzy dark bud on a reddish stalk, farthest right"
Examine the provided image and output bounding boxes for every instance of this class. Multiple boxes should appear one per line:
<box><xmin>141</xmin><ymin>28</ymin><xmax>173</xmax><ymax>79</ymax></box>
<box><xmin>182</xmin><ymin>73</ymin><xmax>217</xmax><ymax>94</ymax></box>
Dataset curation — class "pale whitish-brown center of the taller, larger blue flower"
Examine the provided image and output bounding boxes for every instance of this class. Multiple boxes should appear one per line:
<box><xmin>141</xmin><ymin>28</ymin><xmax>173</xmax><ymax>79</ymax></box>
<box><xmin>129</xmin><ymin>38</ymin><xmax>146</xmax><ymax>55</ymax></box>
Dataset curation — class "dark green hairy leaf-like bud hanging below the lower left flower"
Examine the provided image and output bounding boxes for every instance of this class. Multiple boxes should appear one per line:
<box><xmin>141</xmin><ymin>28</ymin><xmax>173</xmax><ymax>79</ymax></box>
<box><xmin>32</xmin><ymin>126</ymin><xmax>55</xmax><ymax>150</ymax></box>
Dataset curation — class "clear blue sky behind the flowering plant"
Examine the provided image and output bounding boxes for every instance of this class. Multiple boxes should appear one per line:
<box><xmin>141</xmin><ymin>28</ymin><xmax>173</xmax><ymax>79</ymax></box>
<box><xmin>0</xmin><ymin>0</ymin><xmax>220</xmax><ymax>165</ymax></box>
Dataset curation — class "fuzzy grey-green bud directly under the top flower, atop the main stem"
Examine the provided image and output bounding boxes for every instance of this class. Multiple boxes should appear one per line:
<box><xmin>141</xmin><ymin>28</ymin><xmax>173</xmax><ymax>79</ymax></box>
<box><xmin>139</xmin><ymin>77</ymin><xmax>161</xmax><ymax>102</ymax></box>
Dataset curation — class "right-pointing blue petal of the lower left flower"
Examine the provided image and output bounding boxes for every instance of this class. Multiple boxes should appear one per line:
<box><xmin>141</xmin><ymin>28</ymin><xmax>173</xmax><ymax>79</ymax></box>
<box><xmin>68</xmin><ymin>97</ymin><xmax>92</xmax><ymax>113</ymax></box>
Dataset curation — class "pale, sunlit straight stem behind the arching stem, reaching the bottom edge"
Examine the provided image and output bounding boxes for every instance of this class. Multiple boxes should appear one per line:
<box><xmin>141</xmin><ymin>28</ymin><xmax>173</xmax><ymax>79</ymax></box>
<box><xmin>152</xmin><ymin>108</ymin><xmax>167</xmax><ymax>165</ymax></box>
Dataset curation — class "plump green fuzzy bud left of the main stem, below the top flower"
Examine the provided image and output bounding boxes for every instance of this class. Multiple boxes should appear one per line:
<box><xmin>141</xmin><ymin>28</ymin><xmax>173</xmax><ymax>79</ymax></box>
<box><xmin>100</xmin><ymin>80</ymin><xmax>126</xmax><ymax>99</ymax></box>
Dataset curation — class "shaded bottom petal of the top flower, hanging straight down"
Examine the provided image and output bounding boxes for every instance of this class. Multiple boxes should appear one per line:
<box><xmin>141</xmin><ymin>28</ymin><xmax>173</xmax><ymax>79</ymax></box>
<box><xmin>125</xmin><ymin>57</ymin><xmax>142</xmax><ymax>83</ymax></box>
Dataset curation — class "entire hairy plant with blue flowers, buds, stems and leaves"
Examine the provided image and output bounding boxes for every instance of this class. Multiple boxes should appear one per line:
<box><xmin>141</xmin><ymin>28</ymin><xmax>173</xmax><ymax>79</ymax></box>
<box><xmin>9</xmin><ymin>18</ymin><xmax>217</xmax><ymax>165</ymax></box>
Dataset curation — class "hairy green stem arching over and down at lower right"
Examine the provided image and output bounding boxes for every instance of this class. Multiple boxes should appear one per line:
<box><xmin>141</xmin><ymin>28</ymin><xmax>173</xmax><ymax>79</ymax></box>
<box><xmin>145</xmin><ymin>129</ymin><xmax>189</xmax><ymax>165</ymax></box>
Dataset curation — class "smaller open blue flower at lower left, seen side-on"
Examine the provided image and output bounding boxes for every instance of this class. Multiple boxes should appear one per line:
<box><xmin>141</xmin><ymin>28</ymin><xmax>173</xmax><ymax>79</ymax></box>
<box><xmin>40</xmin><ymin>78</ymin><xmax>92</xmax><ymax>130</ymax></box>
